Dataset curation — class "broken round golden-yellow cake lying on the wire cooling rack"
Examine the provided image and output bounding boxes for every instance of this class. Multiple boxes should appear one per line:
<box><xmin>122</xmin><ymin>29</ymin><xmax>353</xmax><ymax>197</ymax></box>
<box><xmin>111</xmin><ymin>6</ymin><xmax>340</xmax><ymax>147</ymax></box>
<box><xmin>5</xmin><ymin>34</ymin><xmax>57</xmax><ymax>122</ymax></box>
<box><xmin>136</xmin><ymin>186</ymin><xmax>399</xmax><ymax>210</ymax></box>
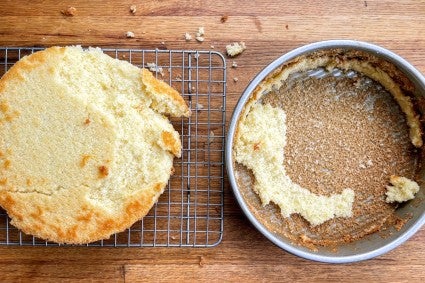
<box><xmin>0</xmin><ymin>47</ymin><xmax>190</xmax><ymax>244</ymax></box>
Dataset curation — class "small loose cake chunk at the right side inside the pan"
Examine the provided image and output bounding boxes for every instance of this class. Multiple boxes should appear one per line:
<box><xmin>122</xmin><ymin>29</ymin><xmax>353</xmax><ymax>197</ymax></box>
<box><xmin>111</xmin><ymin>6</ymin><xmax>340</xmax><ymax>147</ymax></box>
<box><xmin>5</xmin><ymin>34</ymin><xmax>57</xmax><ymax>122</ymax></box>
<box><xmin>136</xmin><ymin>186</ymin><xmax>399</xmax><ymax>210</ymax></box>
<box><xmin>385</xmin><ymin>175</ymin><xmax>419</xmax><ymax>203</ymax></box>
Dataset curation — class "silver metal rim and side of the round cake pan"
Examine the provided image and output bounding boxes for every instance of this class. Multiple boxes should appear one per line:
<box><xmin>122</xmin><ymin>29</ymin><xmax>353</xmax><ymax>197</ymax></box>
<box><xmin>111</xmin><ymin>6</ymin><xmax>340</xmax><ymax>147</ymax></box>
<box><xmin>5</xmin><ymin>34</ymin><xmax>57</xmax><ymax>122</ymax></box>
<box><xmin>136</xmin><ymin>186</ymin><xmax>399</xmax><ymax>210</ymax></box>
<box><xmin>225</xmin><ymin>40</ymin><xmax>425</xmax><ymax>263</ymax></box>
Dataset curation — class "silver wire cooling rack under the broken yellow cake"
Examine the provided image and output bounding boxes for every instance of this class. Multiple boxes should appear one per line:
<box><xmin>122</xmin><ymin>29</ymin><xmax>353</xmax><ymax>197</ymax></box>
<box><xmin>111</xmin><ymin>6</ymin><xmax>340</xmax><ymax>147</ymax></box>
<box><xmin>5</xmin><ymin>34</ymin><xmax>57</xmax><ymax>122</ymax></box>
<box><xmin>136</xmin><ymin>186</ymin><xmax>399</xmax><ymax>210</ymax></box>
<box><xmin>0</xmin><ymin>47</ymin><xmax>226</xmax><ymax>247</ymax></box>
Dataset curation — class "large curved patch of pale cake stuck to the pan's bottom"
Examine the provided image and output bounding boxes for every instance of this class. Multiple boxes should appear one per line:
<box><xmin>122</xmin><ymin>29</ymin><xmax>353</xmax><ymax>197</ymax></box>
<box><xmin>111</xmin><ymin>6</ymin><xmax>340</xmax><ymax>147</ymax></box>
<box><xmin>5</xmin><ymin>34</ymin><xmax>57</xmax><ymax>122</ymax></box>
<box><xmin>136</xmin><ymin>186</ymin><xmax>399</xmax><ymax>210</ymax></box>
<box><xmin>235</xmin><ymin>103</ymin><xmax>354</xmax><ymax>226</ymax></box>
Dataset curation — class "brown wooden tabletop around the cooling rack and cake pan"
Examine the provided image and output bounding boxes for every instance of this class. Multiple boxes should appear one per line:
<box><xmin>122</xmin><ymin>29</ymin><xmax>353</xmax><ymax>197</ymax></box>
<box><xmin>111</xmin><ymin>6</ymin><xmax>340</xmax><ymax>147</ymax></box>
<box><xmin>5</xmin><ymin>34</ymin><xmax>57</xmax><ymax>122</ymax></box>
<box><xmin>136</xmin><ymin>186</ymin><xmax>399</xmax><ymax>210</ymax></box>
<box><xmin>0</xmin><ymin>0</ymin><xmax>425</xmax><ymax>282</ymax></box>
